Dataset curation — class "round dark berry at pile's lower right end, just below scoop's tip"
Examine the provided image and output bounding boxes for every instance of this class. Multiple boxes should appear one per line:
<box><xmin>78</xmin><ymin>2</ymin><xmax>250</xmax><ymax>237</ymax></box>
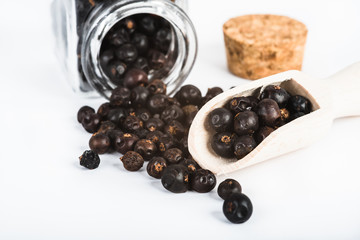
<box><xmin>190</xmin><ymin>169</ymin><xmax>216</xmax><ymax>193</ymax></box>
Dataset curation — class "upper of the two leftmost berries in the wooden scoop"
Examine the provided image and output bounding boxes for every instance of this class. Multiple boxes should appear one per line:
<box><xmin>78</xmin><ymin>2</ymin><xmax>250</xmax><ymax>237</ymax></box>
<box><xmin>208</xmin><ymin>108</ymin><xmax>233</xmax><ymax>132</ymax></box>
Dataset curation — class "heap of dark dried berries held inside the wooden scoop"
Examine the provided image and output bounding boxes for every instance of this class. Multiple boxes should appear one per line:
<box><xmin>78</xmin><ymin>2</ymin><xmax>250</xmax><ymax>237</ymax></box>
<box><xmin>207</xmin><ymin>85</ymin><xmax>312</xmax><ymax>159</ymax></box>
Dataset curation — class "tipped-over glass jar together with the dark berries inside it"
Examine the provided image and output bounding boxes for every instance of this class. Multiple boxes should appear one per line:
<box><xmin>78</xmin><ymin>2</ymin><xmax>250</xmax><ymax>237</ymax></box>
<box><xmin>52</xmin><ymin>0</ymin><xmax>197</xmax><ymax>98</ymax></box>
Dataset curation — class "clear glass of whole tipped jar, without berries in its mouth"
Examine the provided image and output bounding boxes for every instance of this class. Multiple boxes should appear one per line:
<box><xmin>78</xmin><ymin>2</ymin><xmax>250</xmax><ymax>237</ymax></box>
<box><xmin>52</xmin><ymin>0</ymin><xmax>197</xmax><ymax>98</ymax></box>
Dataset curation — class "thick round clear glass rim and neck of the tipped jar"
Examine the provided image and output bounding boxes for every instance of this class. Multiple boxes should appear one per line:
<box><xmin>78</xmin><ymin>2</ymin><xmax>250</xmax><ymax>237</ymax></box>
<box><xmin>81</xmin><ymin>0</ymin><xmax>197</xmax><ymax>98</ymax></box>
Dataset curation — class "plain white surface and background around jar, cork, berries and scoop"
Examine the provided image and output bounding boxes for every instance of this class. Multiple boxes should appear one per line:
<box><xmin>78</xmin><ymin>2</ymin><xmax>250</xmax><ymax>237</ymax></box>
<box><xmin>0</xmin><ymin>0</ymin><xmax>360</xmax><ymax>239</ymax></box>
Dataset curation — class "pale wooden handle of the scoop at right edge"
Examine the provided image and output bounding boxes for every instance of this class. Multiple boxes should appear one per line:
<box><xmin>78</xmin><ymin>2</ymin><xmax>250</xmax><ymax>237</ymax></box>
<box><xmin>324</xmin><ymin>62</ymin><xmax>360</xmax><ymax>118</ymax></box>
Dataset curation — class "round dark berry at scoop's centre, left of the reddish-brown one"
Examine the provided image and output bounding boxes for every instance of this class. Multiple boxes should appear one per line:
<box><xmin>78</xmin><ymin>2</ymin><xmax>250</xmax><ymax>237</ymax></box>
<box><xmin>234</xmin><ymin>111</ymin><xmax>259</xmax><ymax>135</ymax></box>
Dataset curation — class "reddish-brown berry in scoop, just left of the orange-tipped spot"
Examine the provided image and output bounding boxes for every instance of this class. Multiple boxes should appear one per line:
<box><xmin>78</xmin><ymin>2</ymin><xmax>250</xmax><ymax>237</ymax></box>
<box><xmin>255</xmin><ymin>98</ymin><xmax>281</xmax><ymax>127</ymax></box>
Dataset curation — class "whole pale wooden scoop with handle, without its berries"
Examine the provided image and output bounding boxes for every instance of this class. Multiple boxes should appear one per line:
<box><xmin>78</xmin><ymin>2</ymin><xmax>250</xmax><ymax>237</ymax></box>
<box><xmin>188</xmin><ymin>62</ymin><xmax>360</xmax><ymax>175</ymax></box>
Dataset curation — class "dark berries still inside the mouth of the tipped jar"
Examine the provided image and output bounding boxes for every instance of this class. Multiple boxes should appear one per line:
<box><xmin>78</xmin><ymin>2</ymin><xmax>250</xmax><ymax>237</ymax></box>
<box><xmin>100</xmin><ymin>14</ymin><xmax>173</xmax><ymax>89</ymax></box>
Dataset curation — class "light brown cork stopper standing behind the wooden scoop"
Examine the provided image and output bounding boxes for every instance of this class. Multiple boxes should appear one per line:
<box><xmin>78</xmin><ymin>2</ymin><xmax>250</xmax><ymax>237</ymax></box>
<box><xmin>223</xmin><ymin>15</ymin><xmax>307</xmax><ymax>80</ymax></box>
